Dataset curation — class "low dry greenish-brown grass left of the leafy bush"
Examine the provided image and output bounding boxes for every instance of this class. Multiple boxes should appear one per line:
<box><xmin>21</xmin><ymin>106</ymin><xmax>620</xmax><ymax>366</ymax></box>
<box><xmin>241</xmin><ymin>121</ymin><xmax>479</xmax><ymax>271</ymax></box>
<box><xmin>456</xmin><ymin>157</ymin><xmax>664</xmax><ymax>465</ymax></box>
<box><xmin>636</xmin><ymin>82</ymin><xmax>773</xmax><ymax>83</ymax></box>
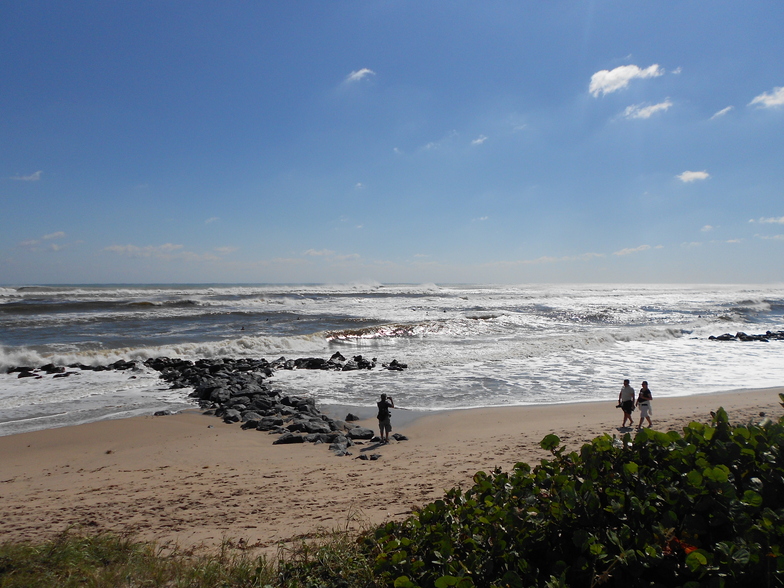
<box><xmin>0</xmin><ymin>531</ymin><xmax>376</xmax><ymax>588</ymax></box>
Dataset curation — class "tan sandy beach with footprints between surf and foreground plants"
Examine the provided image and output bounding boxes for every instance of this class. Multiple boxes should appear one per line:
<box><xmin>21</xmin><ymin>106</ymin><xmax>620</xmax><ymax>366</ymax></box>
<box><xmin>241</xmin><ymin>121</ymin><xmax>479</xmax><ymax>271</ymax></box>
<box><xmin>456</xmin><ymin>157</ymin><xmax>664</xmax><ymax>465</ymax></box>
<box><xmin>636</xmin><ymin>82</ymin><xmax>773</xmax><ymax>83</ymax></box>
<box><xmin>0</xmin><ymin>388</ymin><xmax>784</xmax><ymax>555</ymax></box>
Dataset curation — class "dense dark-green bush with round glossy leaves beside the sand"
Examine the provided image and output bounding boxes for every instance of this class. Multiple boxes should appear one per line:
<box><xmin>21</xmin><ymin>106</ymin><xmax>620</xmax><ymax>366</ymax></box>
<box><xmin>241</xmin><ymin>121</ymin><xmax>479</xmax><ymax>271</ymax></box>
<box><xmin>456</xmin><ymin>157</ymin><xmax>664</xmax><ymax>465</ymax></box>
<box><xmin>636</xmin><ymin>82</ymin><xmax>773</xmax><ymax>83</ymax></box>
<box><xmin>374</xmin><ymin>409</ymin><xmax>784</xmax><ymax>588</ymax></box>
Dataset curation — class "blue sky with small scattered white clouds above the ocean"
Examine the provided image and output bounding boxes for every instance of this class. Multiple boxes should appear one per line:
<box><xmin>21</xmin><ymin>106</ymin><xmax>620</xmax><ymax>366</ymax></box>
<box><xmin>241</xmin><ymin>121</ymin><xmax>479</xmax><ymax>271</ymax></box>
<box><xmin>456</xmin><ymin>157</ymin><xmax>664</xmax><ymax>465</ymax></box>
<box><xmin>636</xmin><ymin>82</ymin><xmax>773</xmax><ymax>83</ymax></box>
<box><xmin>0</xmin><ymin>0</ymin><xmax>784</xmax><ymax>285</ymax></box>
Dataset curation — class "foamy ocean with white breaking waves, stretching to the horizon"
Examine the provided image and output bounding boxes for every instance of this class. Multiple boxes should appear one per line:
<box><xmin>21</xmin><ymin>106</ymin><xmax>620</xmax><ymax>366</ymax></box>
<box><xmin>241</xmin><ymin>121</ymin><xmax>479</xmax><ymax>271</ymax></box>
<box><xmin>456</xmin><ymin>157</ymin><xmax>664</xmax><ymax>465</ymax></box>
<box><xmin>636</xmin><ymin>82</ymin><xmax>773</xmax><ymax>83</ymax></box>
<box><xmin>0</xmin><ymin>284</ymin><xmax>784</xmax><ymax>435</ymax></box>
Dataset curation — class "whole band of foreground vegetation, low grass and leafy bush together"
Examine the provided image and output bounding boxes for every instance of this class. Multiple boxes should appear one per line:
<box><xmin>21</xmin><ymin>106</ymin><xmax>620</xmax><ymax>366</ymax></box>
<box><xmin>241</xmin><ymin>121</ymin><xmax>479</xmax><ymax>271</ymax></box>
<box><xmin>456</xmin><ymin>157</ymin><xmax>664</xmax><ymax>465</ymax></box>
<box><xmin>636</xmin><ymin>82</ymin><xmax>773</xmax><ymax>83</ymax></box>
<box><xmin>0</xmin><ymin>397</ymin><xmax>784</xmax><ymax>588</ymax></box>
